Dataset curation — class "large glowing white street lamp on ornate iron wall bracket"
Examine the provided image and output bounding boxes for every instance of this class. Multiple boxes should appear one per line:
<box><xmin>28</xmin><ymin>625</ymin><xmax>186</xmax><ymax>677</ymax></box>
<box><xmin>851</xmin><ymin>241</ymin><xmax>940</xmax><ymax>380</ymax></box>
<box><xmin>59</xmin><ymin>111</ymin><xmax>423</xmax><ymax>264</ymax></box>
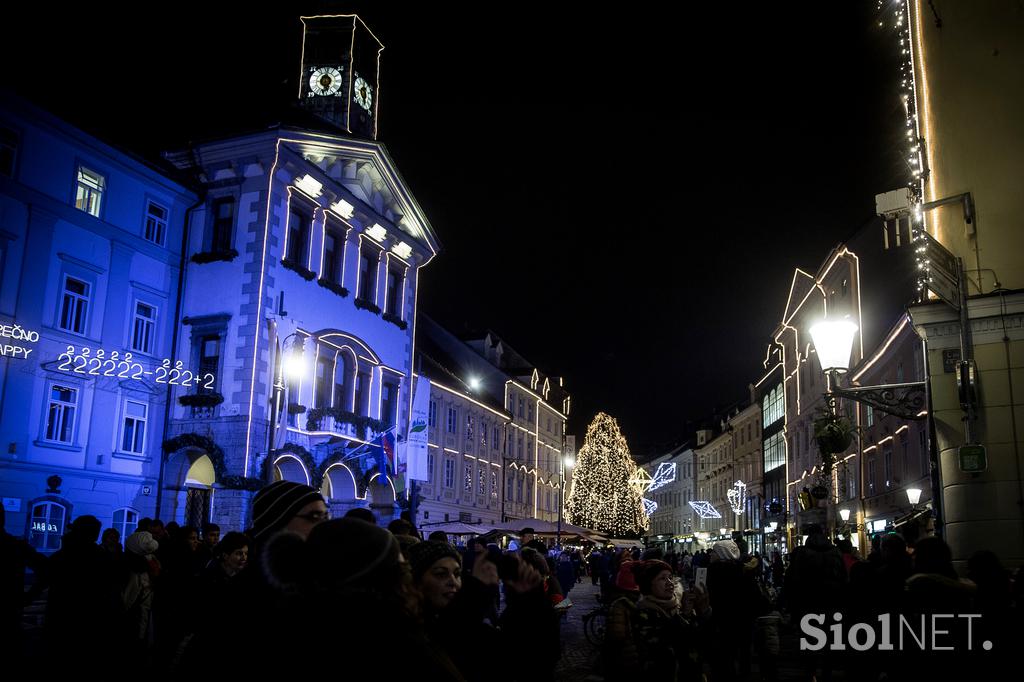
<box><xmin>810</xmin><ymin>319</ymin><xmax>926</xmax><ymax>544</ymax></box>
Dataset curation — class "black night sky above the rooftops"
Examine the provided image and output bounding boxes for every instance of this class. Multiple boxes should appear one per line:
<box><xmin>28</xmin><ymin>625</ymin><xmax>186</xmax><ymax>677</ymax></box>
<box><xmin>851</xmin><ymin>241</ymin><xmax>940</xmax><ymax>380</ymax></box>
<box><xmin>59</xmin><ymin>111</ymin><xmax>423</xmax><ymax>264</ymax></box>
<box><xmin>0</xmin><ymin>2</ymin><xmax>905</xmax><ymax>453</ymax></box>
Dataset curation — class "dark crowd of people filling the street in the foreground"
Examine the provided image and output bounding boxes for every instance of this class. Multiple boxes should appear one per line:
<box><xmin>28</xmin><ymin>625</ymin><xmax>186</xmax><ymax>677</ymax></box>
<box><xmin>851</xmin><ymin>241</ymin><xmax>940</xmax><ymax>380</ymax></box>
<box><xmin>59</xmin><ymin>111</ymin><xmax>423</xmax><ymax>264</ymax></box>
<box><xmin>0</xmin><ymin>481</ymin><xmax>1024</xmax><ymax>682</ymax></box>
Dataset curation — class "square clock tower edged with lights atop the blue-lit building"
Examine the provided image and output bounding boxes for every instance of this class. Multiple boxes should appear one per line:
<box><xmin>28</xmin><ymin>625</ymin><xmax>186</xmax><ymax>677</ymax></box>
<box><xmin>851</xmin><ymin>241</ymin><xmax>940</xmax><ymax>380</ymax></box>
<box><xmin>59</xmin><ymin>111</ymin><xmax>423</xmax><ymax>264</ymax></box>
<box><xmin>299</xmin><ymin>14</ymin><xmax>384</xmax><ymax>139</ymax></box>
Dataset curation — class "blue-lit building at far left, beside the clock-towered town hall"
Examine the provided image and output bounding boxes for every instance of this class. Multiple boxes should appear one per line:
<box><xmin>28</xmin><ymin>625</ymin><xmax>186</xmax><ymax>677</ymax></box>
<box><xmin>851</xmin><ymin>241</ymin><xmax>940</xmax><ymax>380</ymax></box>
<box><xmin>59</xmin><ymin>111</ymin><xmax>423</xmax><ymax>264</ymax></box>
<box><xmin>0</xmin><ymin>91</ymin><xmax>198</xmax><ymax>550</ymax></box>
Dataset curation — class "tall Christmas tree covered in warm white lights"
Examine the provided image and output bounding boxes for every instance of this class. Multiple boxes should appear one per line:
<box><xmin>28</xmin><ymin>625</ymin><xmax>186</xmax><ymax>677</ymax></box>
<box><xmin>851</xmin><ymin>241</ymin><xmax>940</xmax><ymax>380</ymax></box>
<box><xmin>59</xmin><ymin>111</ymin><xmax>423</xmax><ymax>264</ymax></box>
<box><xmin>565</xmin><ymin>412</ymin><xmax>648</xmax><ymax>536</ymax></box>
